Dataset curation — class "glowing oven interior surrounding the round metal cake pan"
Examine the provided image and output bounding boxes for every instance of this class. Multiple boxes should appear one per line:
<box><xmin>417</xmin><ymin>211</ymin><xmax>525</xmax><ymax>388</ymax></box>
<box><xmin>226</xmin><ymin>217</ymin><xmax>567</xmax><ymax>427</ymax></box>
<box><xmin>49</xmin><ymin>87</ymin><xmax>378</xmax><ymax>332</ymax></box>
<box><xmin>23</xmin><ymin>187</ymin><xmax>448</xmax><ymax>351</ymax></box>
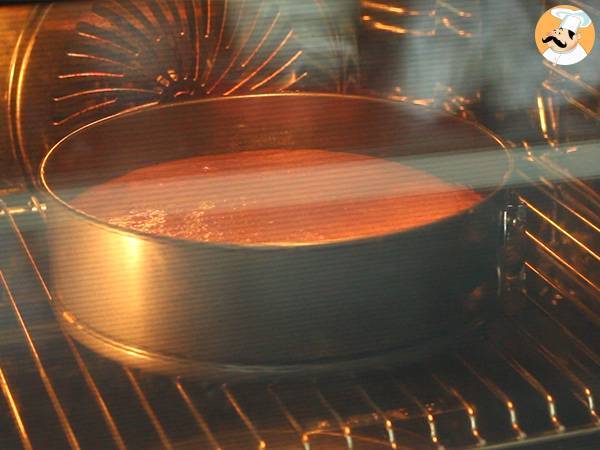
<box><xmin>0</xmin><ymin>0</ymin><xmax>600</xmax><ymax>450</ymax></box>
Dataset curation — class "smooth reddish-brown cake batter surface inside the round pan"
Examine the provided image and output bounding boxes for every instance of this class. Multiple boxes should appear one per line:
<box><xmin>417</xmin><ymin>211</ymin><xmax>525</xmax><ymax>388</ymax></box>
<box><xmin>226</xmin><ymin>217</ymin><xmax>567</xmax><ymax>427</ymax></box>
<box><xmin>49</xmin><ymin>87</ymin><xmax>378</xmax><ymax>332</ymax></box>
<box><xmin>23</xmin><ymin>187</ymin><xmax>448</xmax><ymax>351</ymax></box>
<box><xmin>72</xmin><ymin>149</ymin><xmax>481</xmax><ymax>245</ymax></box>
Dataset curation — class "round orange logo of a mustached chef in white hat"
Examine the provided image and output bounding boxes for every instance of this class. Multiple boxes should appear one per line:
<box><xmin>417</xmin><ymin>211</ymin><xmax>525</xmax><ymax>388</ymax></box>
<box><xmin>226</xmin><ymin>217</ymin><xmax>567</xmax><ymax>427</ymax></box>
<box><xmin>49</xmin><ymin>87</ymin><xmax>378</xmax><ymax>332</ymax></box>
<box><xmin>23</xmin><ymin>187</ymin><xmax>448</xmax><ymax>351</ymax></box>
<box><xmin>535</xmin><ymin>5</ymin><xmax>596</xmax><ymax>66</ymax></box>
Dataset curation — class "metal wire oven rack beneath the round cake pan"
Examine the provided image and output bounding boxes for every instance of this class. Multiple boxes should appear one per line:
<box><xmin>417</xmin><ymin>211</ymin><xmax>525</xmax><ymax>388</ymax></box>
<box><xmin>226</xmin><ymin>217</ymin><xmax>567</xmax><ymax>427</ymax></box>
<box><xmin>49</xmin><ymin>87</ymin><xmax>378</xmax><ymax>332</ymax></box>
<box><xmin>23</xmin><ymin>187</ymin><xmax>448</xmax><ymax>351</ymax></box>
<box><xmin>0</xmin><ymin>149</ymin><xmax>600</xmax><ymax>450</ymax></box>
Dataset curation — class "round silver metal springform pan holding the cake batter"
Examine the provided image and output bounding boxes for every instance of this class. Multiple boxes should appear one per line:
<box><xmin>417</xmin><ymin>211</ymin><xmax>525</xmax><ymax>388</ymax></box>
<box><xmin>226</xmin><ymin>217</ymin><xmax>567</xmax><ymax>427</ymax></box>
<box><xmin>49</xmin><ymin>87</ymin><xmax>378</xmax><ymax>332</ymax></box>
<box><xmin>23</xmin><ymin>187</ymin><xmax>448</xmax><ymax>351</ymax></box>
<box><xmin>40</xmin><ymin>94</ymin><xmax>511</xmax><ymax>379</ymax></box>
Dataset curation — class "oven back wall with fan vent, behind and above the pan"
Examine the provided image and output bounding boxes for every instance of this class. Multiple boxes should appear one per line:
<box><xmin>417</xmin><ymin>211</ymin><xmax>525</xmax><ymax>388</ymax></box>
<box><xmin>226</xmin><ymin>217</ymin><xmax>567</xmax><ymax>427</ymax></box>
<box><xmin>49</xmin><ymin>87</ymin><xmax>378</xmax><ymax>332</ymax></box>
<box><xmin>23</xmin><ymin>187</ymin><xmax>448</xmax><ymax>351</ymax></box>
<box><xmin>2</xmin><ymin>0</ymin><xmax>600</xmax><ymax>185</ymax></box>
